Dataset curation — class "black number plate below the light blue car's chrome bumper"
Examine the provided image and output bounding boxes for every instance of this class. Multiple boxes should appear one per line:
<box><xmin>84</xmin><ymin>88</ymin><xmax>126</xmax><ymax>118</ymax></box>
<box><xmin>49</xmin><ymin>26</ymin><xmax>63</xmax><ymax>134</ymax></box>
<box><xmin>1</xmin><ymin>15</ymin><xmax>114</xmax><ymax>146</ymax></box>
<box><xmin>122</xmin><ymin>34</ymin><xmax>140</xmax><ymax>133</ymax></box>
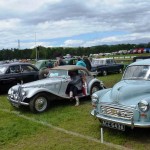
<box><xmin>102</xmin><ymin>120</ymin><xmax>125</xmax><ymax>131</ymax></box>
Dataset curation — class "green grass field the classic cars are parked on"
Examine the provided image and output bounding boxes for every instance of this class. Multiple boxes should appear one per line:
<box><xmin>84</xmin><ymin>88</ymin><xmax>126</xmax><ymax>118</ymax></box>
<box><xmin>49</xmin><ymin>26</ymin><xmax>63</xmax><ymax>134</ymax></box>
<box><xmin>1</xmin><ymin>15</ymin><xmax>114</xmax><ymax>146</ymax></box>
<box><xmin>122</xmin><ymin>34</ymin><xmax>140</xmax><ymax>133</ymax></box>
<box><xmin>0</xmin><ymin>74</ymin><xmax>150</xmax><ymax>150</ymax></box>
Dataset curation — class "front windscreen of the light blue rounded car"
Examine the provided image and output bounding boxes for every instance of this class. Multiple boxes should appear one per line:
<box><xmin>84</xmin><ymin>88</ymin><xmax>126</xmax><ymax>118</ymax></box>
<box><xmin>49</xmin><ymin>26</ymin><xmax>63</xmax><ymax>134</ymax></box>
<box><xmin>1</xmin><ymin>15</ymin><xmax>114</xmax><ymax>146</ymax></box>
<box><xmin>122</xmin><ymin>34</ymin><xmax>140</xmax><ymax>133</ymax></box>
<box><xmin>123</xmin><ymin>65</ymin><xmax>150</xmax><ymax>80</ymax></box>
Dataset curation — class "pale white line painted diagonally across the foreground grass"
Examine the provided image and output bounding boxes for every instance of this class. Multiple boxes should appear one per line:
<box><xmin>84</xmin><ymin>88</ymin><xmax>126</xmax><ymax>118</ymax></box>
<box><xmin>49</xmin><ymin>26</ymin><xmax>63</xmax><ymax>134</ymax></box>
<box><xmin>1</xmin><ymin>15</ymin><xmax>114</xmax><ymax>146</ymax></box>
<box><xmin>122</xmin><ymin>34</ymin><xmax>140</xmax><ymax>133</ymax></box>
<box><xmin>0</xmin><ymin>109</ymin><xmax>131</xmax><ymax>150</ymax></box>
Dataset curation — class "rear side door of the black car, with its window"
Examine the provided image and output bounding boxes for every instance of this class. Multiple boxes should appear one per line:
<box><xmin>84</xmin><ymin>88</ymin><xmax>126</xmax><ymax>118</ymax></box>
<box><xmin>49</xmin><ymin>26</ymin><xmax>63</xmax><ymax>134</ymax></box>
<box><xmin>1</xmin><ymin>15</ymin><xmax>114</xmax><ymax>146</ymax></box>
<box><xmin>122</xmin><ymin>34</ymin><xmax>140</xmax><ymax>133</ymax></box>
<box><xmin>21</xmin><ymin>64</ymin><xmax>38</xmax><ymax>83</ymax></box>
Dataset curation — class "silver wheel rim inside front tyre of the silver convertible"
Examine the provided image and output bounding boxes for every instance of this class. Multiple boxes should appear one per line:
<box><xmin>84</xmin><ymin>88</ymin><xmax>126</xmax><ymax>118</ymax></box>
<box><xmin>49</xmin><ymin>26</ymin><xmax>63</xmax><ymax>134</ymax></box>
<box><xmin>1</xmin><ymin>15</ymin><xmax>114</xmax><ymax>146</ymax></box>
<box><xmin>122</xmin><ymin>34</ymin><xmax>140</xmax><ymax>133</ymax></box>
<box><xmin>35</xmin><ymin>97</ymin><xmax>47</xmax><ymax>112</ymax></box>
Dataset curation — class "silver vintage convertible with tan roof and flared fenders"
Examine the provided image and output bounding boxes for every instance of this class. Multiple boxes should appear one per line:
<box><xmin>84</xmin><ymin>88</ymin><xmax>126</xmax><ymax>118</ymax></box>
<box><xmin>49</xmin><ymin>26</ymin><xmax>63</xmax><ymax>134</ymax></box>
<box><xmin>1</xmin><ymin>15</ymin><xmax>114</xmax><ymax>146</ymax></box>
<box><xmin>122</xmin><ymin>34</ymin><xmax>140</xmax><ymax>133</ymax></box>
<box><xmin>8</xmin><ymin>65</ymin><xmax>104</xmax><ymax>112</ymax></box>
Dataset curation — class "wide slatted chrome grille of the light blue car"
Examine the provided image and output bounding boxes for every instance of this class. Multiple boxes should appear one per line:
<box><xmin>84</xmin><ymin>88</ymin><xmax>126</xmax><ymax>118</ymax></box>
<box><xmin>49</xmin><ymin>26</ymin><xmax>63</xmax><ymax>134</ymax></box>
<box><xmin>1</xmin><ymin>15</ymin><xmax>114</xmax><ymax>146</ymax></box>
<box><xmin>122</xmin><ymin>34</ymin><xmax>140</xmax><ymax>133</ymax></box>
<box><xmin>101</xmin><ymin>105</ymin><xmax>133</xmax><ymax>120</ymax></box>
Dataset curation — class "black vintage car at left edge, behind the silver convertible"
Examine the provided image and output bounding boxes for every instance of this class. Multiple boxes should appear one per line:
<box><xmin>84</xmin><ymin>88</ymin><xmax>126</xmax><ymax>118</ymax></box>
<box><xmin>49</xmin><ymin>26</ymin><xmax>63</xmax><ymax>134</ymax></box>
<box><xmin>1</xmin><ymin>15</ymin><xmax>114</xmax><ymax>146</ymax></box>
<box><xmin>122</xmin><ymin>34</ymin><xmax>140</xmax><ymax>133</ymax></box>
<box><xmin>0</xmin><ymin>62</ymin><xmax>39</xmax><ymax>93</ymax></box>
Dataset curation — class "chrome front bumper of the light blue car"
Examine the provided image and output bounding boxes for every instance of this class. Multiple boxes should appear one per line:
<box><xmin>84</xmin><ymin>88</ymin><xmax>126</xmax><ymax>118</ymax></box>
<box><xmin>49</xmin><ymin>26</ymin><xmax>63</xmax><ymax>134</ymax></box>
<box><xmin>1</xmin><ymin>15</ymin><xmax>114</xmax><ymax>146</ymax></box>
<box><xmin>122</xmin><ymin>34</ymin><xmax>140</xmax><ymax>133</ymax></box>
<box><xmin>91</xmin><ymin>109</ymin><xmax>150</xmax><ymax>128</ymax></box>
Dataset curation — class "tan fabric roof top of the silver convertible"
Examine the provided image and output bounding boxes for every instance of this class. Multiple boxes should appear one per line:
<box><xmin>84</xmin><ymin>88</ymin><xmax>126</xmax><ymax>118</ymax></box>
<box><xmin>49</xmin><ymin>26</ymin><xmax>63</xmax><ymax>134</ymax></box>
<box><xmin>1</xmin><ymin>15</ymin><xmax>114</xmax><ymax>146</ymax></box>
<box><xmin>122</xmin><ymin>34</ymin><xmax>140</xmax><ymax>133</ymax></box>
<box><xmin>51</xmin><ymin>65</ymin><xmax>87</xmax><ymax>71</ymax></box>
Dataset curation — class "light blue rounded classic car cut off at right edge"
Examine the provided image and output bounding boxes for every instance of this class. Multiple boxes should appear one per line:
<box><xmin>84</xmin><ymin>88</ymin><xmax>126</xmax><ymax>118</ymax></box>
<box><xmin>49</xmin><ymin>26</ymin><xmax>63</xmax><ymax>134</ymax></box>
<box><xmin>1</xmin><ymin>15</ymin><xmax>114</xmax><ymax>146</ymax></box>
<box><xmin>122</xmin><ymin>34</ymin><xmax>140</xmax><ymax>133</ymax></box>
<box><xmin>91</xmin><ymin>59</ymin><xmax>150</xmax><ymax>130</ymax></box>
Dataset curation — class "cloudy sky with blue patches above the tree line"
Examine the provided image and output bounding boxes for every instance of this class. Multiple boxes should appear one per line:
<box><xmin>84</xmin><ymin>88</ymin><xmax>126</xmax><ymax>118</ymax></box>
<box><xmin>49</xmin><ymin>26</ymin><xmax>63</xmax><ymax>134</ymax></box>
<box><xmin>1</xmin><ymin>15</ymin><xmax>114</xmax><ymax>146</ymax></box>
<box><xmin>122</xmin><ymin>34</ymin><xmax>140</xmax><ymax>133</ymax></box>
<box><xmin>0</xmin><ymin>0</ymin><xmax>150</xmax><ymax>50</ymax></box>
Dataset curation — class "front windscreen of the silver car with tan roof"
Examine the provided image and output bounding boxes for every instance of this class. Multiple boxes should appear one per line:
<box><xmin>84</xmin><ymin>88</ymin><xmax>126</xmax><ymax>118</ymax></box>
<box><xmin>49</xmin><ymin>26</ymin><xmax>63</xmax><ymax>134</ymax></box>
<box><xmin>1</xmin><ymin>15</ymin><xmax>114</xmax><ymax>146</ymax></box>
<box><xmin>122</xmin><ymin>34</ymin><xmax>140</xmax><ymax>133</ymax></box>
<box><xmin>48</xmin><ymin>69</ymin><xmax>68</xmax><ymax>77</ymax></box>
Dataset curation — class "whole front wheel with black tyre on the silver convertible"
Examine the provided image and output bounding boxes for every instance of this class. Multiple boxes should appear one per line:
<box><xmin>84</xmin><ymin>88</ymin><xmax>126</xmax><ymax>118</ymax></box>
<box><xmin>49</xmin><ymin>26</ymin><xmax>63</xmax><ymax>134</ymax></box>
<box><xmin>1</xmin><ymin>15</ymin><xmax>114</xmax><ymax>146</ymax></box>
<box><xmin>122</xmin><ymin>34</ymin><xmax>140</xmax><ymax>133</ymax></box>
<box><xmin>29</xmin><ymin>93</ymin><xmax>48</xmax><ymax>113</ymax></box>
